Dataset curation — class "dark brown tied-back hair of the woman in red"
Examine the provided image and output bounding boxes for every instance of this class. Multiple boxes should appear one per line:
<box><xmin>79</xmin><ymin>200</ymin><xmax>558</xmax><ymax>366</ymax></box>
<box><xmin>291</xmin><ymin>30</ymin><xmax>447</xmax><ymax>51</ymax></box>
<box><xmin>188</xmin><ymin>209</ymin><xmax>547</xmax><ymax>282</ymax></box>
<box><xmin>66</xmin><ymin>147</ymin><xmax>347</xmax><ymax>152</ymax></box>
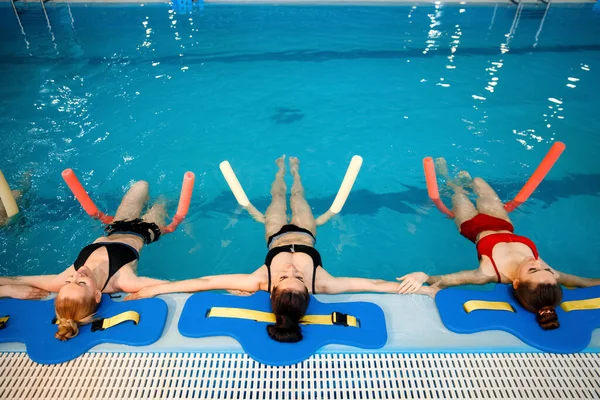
<box><xmin>515</xmin><ymin>283</ymin><xmax>562</xmax><ymax>330</ymax></box>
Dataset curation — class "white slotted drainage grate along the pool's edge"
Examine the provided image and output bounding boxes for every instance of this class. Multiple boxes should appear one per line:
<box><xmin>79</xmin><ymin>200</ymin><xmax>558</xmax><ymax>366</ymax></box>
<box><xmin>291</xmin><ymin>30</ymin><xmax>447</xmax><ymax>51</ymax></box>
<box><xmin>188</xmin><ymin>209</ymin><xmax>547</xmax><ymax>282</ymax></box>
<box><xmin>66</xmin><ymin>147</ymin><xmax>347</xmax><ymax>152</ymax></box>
<box><xmin>0</xmin><ymin>353</ymin><xmax>600</xmax><ymax>400</ymax></box>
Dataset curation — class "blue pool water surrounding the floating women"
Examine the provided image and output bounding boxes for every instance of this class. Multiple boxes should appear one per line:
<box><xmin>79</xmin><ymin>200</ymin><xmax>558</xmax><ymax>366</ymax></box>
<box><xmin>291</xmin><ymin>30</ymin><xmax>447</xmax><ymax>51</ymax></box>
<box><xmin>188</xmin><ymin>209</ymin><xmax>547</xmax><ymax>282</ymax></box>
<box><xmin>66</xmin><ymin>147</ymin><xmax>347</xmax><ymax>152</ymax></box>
<box><xmin>0</xmin><ymin>4</ymin><xmax>600</xmax><ymax>288</ymax></box>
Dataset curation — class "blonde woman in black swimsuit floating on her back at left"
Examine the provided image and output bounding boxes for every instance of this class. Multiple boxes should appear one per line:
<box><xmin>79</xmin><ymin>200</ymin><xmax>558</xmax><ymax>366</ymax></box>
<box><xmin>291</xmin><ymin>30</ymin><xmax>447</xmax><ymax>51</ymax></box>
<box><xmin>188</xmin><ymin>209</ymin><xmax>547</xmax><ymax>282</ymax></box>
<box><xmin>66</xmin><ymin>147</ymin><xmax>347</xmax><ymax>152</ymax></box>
<box><xmin>0</xmin><ymin>181</ymin><xmax>166</xmax><ymax>341</ymax></box>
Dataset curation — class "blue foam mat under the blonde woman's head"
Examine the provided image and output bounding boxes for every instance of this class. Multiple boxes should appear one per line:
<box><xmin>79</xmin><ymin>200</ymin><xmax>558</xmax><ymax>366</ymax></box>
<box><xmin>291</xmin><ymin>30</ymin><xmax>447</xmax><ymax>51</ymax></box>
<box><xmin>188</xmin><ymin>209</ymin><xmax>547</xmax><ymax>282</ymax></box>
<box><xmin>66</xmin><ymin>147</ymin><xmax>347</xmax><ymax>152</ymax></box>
<box><xmin>0</xmin><ymin>294</ymin><xmax>167</xmax><ymax>364</ymax></box>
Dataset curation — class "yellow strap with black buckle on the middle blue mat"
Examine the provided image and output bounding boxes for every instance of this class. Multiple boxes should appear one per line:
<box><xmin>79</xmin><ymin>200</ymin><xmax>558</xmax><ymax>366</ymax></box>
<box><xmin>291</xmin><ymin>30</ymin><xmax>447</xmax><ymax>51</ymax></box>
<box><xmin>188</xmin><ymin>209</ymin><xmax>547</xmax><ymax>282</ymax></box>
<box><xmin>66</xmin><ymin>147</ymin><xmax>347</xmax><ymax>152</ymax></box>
<box><xmin>206</xmin><ymin>307</ymin><xmax>360</xmax><ymax>328</ymax></box>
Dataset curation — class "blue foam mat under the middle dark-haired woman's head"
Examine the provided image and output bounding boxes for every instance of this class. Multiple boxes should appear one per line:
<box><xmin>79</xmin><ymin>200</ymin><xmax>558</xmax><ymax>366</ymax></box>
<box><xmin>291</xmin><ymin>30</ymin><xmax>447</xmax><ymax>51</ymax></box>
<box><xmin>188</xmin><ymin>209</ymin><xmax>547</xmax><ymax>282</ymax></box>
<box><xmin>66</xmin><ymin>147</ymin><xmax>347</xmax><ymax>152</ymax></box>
<box><xmin>179</xmin><ymin>292</ymin><xmax>387</xmax><ymax>365</ymax></box>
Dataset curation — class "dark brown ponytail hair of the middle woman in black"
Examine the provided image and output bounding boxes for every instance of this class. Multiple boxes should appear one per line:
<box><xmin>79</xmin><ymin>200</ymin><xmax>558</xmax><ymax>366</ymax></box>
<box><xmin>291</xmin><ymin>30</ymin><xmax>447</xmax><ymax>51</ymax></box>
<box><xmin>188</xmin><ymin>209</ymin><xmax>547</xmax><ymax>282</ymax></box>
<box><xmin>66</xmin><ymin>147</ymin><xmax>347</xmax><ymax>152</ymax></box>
<box><xmin>267</xmin><ymin>288</ymin><xmax>310</xmax><ymax>343</ymax></box>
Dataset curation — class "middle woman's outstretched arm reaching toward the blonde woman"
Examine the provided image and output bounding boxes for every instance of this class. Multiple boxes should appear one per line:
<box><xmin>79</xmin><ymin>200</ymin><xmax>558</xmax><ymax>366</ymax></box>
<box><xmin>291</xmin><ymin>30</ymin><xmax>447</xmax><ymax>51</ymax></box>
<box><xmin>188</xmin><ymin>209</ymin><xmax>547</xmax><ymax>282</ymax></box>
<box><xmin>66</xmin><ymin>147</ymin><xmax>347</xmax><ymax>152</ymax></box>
<box><xmin>125</xmin><ymin>274</ymin><xmax>260</xmax><ymax>300</ymax></box>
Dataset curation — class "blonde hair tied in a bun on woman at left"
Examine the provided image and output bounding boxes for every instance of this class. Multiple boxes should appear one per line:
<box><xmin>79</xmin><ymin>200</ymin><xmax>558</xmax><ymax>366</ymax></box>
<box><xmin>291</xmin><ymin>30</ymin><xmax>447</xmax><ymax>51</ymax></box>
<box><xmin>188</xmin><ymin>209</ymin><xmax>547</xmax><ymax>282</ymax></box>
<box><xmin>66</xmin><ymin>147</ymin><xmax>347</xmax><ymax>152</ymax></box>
<box><xmin>54</xmin><ymin>296</ymin><xmax>98</xmax><ymax>342</ymax></box>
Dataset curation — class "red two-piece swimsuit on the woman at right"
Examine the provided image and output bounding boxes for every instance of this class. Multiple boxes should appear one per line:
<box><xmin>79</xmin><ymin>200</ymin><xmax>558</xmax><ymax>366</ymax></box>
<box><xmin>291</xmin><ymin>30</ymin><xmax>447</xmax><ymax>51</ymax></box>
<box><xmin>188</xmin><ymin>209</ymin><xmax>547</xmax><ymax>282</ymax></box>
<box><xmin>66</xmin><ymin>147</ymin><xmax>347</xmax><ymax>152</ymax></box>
<box><xmin>460</xmin><ymin>214</ymin><xmax>539</xmax><ymax>283</ymax></box>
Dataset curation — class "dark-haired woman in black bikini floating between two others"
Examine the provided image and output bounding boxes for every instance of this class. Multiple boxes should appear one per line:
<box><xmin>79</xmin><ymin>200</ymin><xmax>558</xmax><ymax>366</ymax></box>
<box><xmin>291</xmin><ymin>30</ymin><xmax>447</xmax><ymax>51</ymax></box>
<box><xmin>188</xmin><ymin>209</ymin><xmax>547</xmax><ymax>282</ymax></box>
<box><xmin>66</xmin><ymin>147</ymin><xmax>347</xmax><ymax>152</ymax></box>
<box><xmin>126</xmin><ymin>157</ymin><xmax>399</xmax><ymax>343</ymax></box>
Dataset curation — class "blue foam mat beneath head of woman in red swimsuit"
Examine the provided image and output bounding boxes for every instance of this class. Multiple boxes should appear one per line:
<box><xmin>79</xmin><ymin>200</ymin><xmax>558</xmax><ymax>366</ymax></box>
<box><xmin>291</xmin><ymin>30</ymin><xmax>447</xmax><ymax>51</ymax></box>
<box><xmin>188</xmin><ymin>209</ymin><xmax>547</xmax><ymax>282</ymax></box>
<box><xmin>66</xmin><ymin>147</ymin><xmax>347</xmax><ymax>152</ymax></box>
<box><xmin>435</xmin><ymin>284</ymin><xmax>600</xmax><ymax>354</ymax></box>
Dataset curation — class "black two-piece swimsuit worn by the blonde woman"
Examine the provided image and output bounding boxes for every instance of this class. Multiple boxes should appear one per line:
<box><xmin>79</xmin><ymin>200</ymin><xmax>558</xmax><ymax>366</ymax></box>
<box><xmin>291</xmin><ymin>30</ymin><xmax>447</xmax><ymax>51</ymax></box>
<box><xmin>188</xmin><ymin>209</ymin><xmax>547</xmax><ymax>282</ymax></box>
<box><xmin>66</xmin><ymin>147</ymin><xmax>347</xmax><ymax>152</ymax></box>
<box><xmin>73</xmin><ymin>219</ymin><xmax>161</xmax><ymax>290</ymax></box>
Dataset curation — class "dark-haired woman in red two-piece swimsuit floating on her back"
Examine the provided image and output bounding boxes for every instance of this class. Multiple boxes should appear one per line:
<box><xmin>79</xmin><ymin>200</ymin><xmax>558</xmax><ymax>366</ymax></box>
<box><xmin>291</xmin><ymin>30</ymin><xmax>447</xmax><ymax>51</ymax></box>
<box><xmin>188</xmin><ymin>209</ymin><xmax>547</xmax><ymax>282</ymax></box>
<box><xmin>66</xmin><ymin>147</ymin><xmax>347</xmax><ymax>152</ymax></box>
<box><xmin>398</xmin><ymin>159</ymin><xmax>600</xmax><ymax>329</ymax></box>
